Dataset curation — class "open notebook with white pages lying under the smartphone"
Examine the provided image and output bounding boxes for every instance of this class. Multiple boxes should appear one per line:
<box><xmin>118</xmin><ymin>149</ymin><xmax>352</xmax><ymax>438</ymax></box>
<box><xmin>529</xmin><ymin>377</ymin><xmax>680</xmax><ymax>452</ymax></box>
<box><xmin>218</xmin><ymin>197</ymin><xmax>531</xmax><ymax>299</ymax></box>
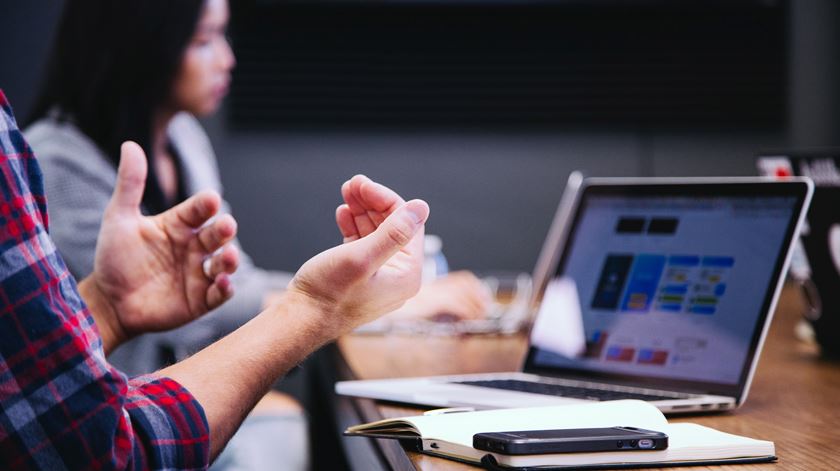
<box><xmin>345</xmin><ymin>400</ymin><xmax>776</xmax><ymax>468</ymax></box>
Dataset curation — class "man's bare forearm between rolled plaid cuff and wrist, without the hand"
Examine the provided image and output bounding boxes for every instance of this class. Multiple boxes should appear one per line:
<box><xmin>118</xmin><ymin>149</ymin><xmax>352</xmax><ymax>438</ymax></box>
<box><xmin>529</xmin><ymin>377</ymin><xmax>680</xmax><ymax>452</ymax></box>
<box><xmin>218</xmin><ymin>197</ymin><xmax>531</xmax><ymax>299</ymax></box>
<box><xmin>158</xmin><ymin>292</ymin><xmax>340</xmax><ymax>459</ymax></box>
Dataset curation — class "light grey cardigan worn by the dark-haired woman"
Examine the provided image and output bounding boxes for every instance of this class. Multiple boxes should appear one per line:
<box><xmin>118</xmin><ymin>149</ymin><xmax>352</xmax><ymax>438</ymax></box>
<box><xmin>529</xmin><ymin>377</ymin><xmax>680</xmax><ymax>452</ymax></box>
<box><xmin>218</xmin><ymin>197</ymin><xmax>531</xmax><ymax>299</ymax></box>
<box><xmin>25</xmin><ymin>113</ymin><xmax>291</xmax><ymax>375</ymax></box>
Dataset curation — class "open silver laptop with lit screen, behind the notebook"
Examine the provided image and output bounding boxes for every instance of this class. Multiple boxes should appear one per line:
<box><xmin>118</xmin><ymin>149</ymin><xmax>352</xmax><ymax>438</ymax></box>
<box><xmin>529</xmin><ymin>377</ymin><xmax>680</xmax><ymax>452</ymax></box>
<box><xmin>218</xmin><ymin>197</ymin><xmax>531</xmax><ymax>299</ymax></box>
<box><xmin>336</xmin><ymin>175</ymin><xmax>813</xmax><ymax>413</ymax></box>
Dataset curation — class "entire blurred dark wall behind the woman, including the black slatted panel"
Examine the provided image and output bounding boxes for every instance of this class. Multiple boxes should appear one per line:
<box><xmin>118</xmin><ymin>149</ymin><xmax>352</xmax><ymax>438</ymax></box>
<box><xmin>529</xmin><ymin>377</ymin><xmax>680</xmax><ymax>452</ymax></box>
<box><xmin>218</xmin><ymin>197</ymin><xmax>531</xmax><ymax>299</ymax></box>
<box><xmin>0</xmin><ymin>0</ymin><xmax>840</xmax><ymax>271</ymax></box>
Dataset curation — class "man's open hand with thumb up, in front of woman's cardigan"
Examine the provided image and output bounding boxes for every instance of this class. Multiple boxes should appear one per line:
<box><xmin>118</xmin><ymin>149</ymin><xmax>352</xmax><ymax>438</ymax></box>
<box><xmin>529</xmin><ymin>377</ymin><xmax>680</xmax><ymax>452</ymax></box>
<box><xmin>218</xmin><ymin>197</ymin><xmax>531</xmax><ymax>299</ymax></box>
<box><xmin>80</xmin><ymin>142</ymin><xmax>239</xmax><ymax>351</ymax></box>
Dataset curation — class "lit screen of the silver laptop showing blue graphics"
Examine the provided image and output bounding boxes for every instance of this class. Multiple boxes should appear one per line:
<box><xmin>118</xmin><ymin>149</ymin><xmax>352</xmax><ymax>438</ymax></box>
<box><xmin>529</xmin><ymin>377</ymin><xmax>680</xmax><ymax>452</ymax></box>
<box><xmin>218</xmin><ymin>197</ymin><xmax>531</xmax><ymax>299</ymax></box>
<box><xmin>526</xmin><ymin>182</ymin><xmax>807</xmax><ymax>395</ymax></box>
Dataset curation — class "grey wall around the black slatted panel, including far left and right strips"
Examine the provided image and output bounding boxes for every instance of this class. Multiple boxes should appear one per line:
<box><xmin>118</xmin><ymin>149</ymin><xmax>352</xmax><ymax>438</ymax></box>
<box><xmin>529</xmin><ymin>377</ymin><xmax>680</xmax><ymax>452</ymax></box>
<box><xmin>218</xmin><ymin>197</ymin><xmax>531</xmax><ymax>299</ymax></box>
<box><xmin>0</xmin><ymin>0</ymin><xmax>840</xmax><ymax>271</ymax></box>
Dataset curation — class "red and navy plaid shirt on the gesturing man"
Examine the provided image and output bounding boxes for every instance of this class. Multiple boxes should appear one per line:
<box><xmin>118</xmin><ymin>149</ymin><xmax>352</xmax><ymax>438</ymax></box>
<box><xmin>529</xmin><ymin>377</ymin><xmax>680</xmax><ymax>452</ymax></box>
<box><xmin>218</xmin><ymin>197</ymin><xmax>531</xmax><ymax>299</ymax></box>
<box><xmin>0</xmin><ymin>91</ymin><xmax>209</xmax><ymax>470</ymax></box>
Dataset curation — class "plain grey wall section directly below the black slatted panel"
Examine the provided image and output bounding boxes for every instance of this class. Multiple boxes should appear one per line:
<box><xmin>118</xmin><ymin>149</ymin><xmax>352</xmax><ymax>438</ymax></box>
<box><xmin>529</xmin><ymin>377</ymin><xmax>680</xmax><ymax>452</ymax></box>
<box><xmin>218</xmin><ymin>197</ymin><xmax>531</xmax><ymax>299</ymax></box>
<box><xmin>207</xmin><ymin>121</ymin><xmax>784</xmax><ymax>271</ymax></box>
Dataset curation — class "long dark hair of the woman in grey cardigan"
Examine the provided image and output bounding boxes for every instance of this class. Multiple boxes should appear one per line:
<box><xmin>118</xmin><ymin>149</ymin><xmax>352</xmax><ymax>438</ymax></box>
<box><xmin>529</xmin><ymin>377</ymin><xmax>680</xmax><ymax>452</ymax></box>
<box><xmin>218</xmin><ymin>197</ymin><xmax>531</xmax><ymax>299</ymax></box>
<box><xmin>27</xmin><ymin>0</ymin><xmax>204</xmax><ymax>213</ymax></box>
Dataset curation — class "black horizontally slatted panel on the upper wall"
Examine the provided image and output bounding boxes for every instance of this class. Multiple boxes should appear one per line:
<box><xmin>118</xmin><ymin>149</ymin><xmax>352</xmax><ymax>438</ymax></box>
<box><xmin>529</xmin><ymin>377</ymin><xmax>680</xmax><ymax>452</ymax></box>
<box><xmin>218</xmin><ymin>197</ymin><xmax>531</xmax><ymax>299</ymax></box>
<box><xmin>229</xmin><ymin>0</ymin><xmax>787</xmax><ymax>130</ymax></box>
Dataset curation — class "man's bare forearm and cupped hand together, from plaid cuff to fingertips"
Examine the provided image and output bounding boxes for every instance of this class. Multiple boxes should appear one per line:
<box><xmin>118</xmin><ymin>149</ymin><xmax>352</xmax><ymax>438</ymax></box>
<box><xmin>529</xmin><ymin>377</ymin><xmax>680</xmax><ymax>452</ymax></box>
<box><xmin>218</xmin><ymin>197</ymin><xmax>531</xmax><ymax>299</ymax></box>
<box><xmin>160</xmin><ymin>176</ymin><xmax>429</xmax><ymax>459</ymax></box>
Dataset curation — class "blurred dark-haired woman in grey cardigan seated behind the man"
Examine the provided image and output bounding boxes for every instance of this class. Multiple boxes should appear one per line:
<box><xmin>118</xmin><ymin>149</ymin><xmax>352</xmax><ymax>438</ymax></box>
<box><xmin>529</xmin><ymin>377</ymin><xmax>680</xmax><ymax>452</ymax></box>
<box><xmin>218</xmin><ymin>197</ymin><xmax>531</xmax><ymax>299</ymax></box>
<box><xmin>26</xmin><ymin>0</ymin><xmax>487</xmax><ymax>469</ymax></box>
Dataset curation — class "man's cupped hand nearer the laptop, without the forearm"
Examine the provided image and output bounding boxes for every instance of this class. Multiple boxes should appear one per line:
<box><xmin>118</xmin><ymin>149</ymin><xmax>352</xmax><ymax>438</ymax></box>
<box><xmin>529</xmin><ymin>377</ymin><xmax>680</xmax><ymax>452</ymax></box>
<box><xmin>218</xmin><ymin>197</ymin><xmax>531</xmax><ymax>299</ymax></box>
<box><xmin>287</xmin><ymin>175</ymin><xmax>429</xmax><ymax>338</ymax></box>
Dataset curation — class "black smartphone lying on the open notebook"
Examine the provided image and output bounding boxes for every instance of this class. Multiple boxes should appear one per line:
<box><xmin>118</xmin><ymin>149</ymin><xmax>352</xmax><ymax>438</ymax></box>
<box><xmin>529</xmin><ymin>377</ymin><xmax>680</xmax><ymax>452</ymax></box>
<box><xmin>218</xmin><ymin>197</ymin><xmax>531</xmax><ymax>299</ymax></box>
<box><xmin>473</xmin><ymin>427</ymin><xmax>668</xmax><ymax>455</ymax></box>
